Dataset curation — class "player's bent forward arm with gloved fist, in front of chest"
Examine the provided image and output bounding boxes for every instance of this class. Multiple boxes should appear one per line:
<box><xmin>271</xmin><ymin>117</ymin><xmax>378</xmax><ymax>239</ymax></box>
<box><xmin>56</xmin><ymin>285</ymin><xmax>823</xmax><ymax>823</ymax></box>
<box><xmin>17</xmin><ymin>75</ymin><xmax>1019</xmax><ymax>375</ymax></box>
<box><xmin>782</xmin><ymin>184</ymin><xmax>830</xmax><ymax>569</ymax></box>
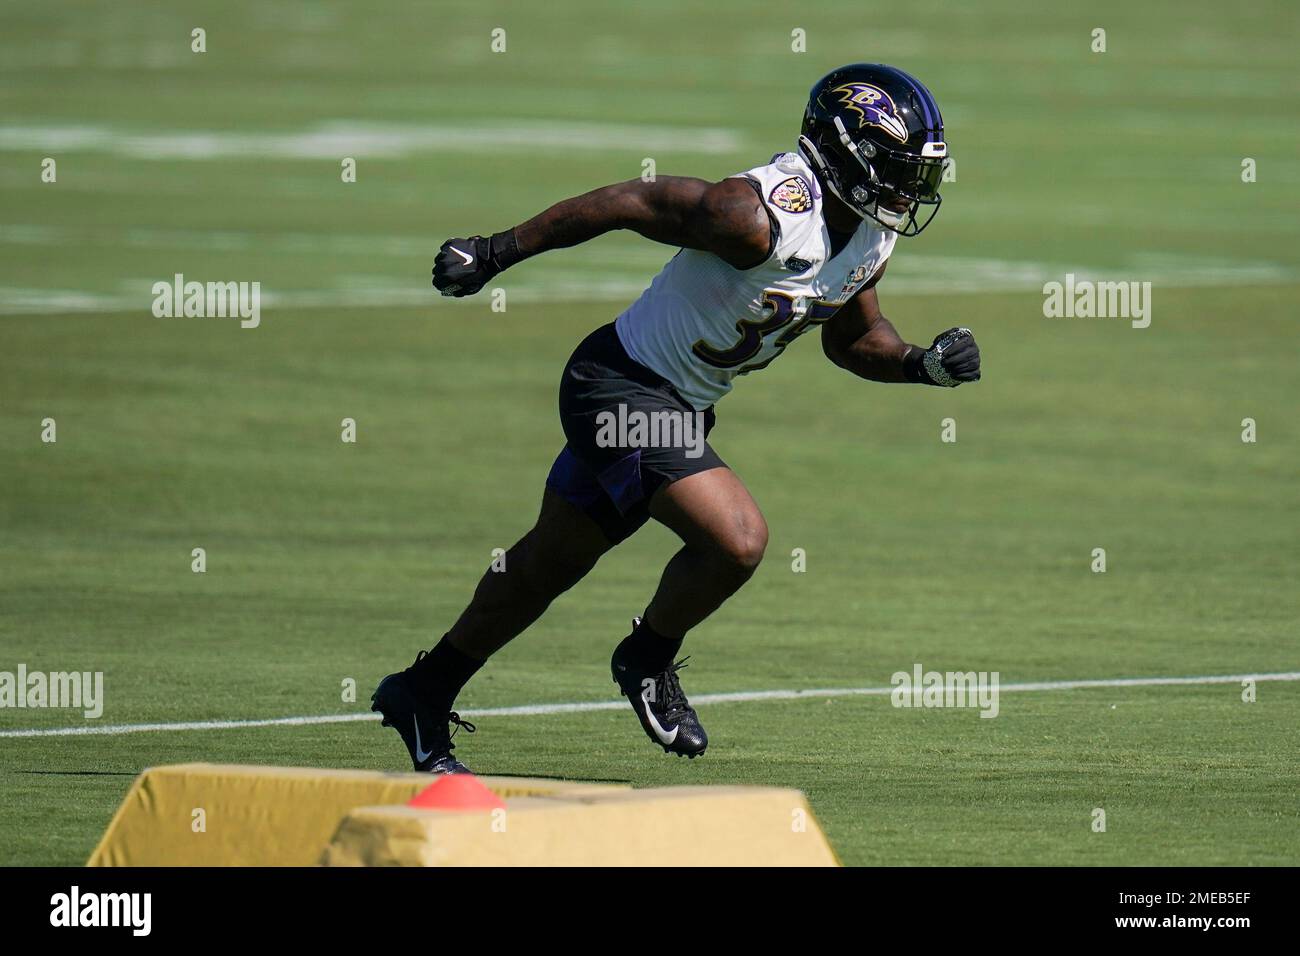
<box><xmin>822</xmin><ymin>265</ymin><xmax>979</xmax><ymax>388</ymax></box>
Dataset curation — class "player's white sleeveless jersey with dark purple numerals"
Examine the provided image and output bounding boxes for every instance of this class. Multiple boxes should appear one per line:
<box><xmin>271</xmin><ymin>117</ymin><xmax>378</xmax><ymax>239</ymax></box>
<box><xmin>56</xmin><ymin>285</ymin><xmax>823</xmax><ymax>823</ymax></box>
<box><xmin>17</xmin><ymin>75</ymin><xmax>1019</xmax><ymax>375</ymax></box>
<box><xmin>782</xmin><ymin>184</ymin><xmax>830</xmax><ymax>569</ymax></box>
<box><xmin>615</xmin><ymin>152</ymin><xmax>897</xmax><ymax>411</ymax></box>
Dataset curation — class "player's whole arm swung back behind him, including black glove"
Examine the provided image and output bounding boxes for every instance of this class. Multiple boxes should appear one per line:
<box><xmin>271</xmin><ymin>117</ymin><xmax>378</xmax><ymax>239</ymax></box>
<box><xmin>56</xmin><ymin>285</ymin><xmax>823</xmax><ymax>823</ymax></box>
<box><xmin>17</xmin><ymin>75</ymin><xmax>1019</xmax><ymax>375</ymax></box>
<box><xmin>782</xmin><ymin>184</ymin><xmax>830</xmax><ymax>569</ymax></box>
<box><xmin>433</xmin><ymin>176</ymin><xmax>774</xmax><ymax>297</ymax></box>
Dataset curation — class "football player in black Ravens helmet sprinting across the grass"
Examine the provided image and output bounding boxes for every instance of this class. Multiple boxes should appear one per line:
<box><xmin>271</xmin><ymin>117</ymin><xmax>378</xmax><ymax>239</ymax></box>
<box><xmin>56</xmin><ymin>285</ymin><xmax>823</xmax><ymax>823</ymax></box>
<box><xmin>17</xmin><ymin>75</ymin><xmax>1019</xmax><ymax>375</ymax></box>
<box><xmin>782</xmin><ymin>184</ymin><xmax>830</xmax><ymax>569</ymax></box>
<box><xmin>373</xmin><ymin>64</ymin><xmax>980</xmax><ymax>773</ymax></box>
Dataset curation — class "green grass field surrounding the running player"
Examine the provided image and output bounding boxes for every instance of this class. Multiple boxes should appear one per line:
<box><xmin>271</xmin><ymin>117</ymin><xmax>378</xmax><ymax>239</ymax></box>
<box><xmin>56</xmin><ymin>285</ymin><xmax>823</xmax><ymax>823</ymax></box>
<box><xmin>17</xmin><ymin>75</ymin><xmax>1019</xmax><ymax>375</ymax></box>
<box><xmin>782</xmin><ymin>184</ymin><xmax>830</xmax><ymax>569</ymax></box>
<box><xmin>0</xmin><ymin>0</ymin><xmax>1300</xmax><ymax>865</ymax></box>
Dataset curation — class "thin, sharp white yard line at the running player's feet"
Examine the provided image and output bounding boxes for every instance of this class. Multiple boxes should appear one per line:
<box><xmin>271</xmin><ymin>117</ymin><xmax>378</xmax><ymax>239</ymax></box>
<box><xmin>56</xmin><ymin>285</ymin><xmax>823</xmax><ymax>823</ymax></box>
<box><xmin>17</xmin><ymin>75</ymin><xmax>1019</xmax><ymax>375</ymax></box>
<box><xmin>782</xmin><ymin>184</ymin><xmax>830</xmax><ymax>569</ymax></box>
<box><xmin>0</xmin><ymin>671</ymin><xmax>1300</xmax><ymax>737</ymax></box>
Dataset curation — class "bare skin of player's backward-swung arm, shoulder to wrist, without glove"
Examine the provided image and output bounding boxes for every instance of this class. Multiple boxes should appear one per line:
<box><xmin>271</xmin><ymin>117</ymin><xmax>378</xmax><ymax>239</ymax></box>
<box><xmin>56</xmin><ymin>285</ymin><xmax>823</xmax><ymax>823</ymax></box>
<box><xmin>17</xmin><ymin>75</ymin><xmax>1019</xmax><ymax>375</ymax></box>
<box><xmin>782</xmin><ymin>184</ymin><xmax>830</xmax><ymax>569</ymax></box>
<box><xmin>515</xmin><ymin>176</ymin><xmax>771</xmax><ymax>269</ymax></box>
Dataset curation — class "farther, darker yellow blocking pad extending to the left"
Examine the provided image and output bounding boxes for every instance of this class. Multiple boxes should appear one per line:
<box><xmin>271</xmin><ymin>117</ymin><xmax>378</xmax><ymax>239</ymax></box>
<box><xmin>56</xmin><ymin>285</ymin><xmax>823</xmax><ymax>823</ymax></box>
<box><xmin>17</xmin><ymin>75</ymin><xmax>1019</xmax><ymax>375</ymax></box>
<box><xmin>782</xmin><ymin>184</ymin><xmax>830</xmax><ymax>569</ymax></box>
<box><xmin>87</xmin><ymin>763</ymin><xmax>628</xmax><ymax>866</ymax></box>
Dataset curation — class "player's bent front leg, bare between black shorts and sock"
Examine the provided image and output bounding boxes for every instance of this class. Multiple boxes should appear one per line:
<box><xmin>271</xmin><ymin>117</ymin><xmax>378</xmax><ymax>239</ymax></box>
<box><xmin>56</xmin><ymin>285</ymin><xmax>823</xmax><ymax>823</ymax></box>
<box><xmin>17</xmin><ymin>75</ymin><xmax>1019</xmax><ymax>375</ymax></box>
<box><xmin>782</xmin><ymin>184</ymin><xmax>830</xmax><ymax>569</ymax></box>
<box><xmin>645</xmin><ymin>468</ymin><xmax>767</xmax><ymax>640</ymax></box>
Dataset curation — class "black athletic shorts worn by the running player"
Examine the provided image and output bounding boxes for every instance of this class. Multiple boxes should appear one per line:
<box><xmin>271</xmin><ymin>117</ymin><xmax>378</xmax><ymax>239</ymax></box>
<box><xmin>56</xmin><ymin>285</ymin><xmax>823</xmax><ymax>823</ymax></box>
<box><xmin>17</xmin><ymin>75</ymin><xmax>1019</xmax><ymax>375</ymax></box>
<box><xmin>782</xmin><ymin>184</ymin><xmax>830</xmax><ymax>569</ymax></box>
<box><xmin>546</xmin><ymin>323</ymin><xmax>727</xmax><ymax>544</ymax></box>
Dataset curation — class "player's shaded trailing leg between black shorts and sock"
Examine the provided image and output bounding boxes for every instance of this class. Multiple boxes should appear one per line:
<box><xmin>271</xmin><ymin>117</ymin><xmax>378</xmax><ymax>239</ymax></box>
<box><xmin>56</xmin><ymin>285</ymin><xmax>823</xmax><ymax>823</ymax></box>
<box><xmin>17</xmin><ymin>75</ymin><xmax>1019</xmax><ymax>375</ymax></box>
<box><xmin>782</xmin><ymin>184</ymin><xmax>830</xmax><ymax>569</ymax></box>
<box><xmin>447</xmin><ymin>488</ymin><xmax>614</xmax><ymax>661</ymax></box>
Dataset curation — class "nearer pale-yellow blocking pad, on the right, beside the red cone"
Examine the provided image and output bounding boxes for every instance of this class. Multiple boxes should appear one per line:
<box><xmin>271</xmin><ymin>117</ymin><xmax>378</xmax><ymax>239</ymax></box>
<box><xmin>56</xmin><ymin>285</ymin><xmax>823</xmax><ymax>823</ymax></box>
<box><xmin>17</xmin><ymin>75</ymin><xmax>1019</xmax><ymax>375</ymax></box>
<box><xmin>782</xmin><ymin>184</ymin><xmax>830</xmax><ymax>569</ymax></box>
<box><xmin>321</xmin><ymin>787</ymin><xmax>840</xmax><ymax>866</ymax></box>
